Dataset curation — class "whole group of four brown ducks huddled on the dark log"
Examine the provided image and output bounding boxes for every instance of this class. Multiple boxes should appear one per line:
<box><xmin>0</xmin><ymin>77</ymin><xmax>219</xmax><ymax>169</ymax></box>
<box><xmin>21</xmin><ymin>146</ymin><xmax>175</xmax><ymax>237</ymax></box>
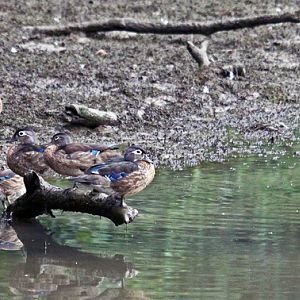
<box><xmin>0</xmin><ymin>127</ymin><xmax>155</xmax><ymax>206</ymax></box>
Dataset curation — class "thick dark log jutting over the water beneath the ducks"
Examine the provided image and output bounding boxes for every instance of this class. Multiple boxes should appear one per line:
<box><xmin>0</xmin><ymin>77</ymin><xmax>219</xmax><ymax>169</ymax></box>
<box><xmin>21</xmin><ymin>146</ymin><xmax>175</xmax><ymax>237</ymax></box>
<box><xmin>5</xmin><ymin>172</ymin><xmax>138</xmax><ymax>226</ymax></box>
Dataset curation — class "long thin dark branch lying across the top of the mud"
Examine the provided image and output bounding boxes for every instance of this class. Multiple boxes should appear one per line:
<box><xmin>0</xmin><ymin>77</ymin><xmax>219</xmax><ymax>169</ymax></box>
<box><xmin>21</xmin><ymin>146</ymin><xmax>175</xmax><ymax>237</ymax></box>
<box><xmin>24</xmin><ymin>10</ymin><xmax>300</xmax><ymax>36</ymax></box>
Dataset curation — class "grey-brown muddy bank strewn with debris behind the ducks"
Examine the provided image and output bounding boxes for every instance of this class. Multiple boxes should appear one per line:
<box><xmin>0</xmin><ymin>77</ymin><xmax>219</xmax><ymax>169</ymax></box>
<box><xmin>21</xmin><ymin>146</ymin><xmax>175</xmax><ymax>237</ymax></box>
<box><xmin>0</xmin><ymin>0</ymin><xmax>300</xmax><ymax>167</ymax></box>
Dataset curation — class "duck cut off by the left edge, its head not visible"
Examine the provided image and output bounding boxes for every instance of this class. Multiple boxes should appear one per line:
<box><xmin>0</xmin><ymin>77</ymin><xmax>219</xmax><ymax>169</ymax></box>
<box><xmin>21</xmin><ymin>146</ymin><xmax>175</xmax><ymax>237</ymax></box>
<box><xmin>0</xmin><ymin>169</ymin><xmax>26</xmax><ymax>207</ymax></box>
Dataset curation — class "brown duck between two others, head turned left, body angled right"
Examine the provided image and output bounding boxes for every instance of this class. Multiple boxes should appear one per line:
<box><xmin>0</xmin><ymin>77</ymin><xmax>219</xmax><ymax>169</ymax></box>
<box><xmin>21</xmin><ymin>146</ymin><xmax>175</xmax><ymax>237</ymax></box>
<box><xmin>44</xmin><ymin>132</ymin><xmax>121</xmax><ymax>176</ymax></box>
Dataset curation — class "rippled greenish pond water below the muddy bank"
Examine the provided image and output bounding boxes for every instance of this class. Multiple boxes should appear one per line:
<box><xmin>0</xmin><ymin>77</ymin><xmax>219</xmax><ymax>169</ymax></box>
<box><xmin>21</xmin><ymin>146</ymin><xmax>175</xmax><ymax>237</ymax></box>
<box><xmin>0</xmin><ymin>156</ymin><xmax>300</xmax><ymax>300</ymax></box>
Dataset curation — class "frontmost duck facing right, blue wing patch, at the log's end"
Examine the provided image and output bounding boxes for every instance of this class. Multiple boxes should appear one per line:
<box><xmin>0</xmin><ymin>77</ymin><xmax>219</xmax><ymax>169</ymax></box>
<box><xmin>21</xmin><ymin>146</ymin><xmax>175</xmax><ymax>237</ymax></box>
<box><xmin>70</xmin><ymin>145</ymin><xmax>155</xmax><ymax>207</ymax></box>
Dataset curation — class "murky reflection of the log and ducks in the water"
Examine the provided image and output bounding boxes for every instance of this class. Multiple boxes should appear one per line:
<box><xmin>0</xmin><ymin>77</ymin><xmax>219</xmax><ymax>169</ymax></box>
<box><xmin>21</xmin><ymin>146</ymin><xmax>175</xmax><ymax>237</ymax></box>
<box><xmin>0</xmin><ymin>221</ymin><xmax>148</xmax><ymax>300</ymax></box>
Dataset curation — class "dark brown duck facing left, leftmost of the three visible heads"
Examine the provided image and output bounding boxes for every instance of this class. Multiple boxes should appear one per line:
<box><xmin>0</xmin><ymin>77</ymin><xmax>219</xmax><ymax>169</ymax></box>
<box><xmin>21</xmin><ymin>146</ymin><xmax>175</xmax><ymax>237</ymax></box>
<box><xmin>7</xmin><ymin>127</ymin><xmax>51</xmax><ymax>176</ymax></box>
